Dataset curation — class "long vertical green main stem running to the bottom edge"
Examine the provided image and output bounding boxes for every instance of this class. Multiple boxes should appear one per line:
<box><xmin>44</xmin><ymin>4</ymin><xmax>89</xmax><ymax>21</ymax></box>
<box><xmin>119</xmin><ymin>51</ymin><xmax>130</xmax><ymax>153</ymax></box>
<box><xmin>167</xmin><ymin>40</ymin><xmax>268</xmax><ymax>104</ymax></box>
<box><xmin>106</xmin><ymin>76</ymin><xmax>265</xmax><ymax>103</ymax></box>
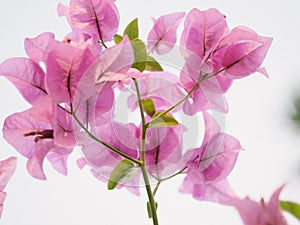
<box><xmin>133</xmin><ymin>78</ymin><xmax>159</xmax><ymax>225</ymax></box>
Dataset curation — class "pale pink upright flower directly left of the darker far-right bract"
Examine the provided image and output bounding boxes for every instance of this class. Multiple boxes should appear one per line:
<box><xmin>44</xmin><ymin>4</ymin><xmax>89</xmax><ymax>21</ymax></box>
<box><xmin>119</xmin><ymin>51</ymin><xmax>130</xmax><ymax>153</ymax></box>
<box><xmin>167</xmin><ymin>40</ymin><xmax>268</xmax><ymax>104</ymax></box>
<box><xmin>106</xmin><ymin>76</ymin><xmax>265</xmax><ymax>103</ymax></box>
<box><xmin>180</xmin><ymin>9</ymin><xmax>231</xmax><ymax>115</ymax></box>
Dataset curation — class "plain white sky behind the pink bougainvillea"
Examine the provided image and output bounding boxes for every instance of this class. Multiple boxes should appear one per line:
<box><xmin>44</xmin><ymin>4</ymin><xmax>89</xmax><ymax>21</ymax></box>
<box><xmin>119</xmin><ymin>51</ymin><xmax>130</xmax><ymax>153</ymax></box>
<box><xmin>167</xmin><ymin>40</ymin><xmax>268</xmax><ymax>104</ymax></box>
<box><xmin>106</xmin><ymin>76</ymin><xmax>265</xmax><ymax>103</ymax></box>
<box><xmin>0</xmin><ymin>0</ymin><xmax>300</xmax><ymax>225</ymax></box>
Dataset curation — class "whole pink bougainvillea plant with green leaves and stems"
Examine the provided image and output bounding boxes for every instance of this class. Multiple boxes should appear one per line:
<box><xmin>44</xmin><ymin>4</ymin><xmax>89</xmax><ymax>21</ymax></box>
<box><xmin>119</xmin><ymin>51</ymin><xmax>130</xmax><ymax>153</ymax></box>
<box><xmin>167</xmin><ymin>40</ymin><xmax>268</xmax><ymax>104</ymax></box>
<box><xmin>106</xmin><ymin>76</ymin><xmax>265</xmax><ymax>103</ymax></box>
<box><xmin>0</xmin><ymin>0</ymin><xmax>298</xmax><ymax>225</ymax></box>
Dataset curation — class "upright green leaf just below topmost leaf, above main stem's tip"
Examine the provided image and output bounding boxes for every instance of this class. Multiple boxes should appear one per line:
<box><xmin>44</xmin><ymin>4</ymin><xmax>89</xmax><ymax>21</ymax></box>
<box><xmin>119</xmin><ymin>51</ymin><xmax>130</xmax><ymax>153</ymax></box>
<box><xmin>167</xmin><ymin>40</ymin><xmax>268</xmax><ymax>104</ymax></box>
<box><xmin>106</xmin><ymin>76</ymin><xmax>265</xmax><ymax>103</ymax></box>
<box><xmin>131</xmin><ymin>39</ymin><xmax>148</xmax><ymax>72</ymax></box>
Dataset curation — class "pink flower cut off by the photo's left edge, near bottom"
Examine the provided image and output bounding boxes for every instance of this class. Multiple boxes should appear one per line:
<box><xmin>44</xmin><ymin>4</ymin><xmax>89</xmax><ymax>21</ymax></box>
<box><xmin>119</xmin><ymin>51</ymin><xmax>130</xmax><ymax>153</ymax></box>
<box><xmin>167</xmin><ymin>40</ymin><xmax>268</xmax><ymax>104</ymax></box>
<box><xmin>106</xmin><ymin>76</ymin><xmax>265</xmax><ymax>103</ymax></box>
<box><xmin>0</xmin><ymin>157</ymin><xmax>17</xmax><ymax>218</ymax></box>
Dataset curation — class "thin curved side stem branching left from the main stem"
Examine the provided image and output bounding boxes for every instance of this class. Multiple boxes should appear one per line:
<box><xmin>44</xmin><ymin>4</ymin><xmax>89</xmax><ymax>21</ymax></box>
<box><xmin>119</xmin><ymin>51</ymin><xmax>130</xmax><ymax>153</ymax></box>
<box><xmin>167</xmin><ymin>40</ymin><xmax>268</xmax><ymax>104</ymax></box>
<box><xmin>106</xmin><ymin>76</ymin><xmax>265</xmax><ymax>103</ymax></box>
<box><xmin>72</xmin><ymin>113</ymin><xmax>143</xmax><ymax>165</ymax></box>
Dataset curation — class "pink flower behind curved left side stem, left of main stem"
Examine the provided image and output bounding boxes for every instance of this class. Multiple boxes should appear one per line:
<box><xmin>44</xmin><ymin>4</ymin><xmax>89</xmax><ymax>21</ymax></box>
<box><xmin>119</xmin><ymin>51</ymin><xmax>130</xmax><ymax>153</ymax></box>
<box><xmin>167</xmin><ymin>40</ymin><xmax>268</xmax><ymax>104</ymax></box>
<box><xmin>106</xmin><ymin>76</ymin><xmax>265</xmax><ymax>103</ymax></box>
<box><xmin>79</xmin><ymin>121</ymin><xmax>140</xmax><ymax>195</ymax></box>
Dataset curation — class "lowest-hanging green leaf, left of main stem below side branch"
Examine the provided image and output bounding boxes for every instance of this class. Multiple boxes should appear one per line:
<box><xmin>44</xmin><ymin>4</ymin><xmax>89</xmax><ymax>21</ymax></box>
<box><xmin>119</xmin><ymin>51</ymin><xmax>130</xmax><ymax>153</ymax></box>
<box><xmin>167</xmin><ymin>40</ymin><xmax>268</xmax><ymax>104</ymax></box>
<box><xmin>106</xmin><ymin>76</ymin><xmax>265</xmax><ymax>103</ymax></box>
<box><xmin>107</xmin><ymin>159</ymin><xmax>138</xmax><ymax>190</ymax></box>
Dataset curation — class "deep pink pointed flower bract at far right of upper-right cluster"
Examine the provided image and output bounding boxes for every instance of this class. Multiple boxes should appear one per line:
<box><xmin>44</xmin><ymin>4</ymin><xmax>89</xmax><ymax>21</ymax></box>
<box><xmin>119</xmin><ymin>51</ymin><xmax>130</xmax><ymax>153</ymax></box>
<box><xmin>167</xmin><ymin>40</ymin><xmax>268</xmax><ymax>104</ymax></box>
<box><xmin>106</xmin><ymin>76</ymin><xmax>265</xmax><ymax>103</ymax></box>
<box><xmin>213</xmin><ymin>27</ymin><xmax>272</xmax><ymax>79</ymax></box>
